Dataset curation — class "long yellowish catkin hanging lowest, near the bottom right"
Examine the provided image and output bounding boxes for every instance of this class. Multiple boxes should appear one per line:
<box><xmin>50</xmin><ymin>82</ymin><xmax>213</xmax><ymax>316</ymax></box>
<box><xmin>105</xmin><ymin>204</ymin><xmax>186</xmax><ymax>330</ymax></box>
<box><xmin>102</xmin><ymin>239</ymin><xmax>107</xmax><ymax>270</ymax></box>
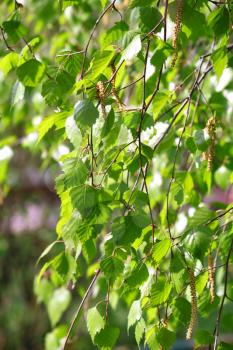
<box><xmin>186</xmin><ymin>269</ymin><xmax>197</xmax><ymax>340</ymax></box>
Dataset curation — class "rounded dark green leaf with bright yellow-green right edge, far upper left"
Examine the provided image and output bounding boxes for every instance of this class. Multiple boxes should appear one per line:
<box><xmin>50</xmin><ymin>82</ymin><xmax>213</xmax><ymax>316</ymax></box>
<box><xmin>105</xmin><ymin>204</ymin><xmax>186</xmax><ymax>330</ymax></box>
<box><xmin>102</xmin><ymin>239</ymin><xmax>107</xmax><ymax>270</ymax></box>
<box><xmin>17</xmin><ymin>58</ymin><xmax>45</xmax><ymax>87</ymax></box>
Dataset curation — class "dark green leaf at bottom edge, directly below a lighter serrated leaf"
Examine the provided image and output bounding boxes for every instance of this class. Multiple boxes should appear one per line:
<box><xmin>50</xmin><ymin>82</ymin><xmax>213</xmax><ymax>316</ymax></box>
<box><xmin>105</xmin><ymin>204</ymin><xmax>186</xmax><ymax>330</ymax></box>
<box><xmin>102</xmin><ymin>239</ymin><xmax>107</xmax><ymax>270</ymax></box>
<box><xmin>94</xmin><ymin>326</ymin><xmax>120</xmax><ymax>349</ymax></box>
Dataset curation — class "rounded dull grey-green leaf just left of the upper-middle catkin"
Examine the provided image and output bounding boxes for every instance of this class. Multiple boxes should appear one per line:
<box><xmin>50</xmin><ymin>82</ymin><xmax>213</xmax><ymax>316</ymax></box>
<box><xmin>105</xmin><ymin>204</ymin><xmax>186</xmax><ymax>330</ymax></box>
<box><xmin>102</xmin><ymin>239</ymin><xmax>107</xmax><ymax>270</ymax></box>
<box><xmin>74</xmin><ymin>100</ymin><xmax>99</xmax><ymax>128</ymax></box>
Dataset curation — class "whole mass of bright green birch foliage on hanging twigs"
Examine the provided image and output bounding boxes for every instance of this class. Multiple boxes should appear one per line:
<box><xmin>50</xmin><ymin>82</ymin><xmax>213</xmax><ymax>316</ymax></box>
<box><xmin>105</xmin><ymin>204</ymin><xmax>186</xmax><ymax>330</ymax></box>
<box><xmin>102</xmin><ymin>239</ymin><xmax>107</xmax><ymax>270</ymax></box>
<box><xmin>0</xmin><ymin>0</ymin><xmax>233</xmax><ymax>350</ymax></box>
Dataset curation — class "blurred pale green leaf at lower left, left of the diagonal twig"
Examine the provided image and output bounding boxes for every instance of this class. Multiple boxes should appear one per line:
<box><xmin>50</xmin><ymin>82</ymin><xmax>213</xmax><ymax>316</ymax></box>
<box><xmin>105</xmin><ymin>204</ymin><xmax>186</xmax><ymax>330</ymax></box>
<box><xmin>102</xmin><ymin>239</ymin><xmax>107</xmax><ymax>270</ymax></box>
<box><xmin>47</xmin><ymin>287</ymin><xmax>71</xmax><ymax>326</ymax></box>
